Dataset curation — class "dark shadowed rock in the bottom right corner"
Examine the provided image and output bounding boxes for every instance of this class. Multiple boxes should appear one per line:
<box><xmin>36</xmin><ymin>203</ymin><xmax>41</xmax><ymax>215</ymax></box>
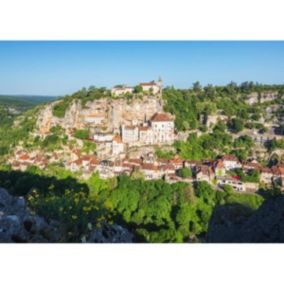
<box><xmin>208</xmin><ymin>196</ymin><xmax>284</xmax><ymax>243</ymax></box>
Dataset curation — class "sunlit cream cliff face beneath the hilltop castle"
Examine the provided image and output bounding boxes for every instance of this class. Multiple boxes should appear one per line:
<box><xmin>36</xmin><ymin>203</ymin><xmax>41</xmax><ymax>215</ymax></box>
<box><xmin>37</xmin><ymin>96</ymin><xmax>163</xmax><ymax>135</ymax></box>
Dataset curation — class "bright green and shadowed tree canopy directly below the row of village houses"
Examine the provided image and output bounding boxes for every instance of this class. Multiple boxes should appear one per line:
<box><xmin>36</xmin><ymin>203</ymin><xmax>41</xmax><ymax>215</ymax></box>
<box><xmin>0</xmin><ymin>167</ymin><xmax>263</xmax><ymax>242</ymax></box>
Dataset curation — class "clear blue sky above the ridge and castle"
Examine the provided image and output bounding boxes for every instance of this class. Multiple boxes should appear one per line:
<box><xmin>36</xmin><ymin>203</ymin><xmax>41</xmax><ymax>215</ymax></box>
<box><xmin>0</xmin><ymin>41</ymin><xmax>284</xmax><ymax>95</ymax></box>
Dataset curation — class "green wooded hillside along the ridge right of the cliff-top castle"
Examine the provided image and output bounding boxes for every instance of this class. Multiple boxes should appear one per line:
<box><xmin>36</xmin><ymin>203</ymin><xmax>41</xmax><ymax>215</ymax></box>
<box><xmin>163</xmin><ymin>82</ymin><xmax>284</xmax><ymax>132</ymax></box>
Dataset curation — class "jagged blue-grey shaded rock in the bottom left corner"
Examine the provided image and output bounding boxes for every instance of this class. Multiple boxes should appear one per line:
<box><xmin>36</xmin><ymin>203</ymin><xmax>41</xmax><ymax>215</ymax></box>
<box><xmin>0</xmin><ymin>188</ymin><xmax>60</xmax><ymax>243</ymax></box>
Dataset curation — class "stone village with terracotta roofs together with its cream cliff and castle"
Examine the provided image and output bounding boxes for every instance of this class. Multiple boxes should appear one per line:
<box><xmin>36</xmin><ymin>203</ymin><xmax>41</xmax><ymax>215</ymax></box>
<box><xmin>6</xmin><ymin>80</ymin><xmax>284</xmax><ymax>192</ymax></box>
